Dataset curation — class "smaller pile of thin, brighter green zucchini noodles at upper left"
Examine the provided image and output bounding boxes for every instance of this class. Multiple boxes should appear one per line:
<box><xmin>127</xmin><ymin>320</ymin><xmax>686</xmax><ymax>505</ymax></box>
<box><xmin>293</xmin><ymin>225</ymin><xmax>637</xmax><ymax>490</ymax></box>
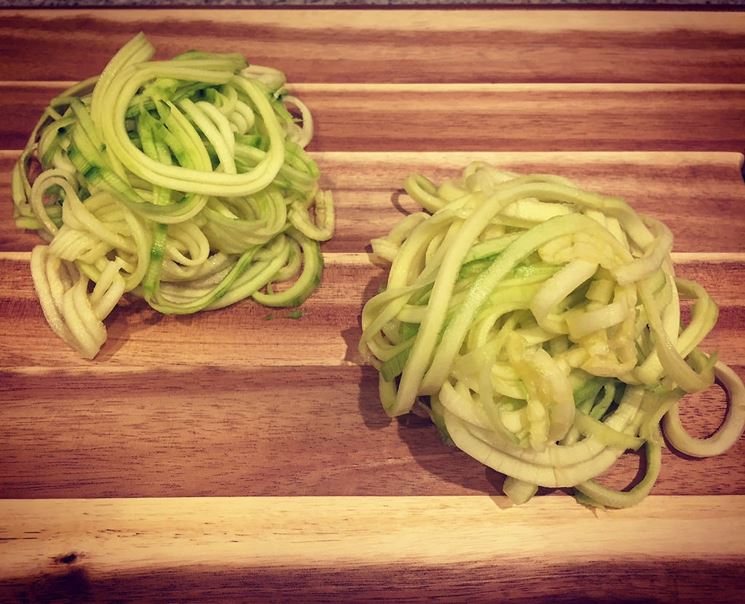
<box><xmin>12</xmin><ymin>34</ymin><xmax>335</xmax><ymax>359</ymax></box>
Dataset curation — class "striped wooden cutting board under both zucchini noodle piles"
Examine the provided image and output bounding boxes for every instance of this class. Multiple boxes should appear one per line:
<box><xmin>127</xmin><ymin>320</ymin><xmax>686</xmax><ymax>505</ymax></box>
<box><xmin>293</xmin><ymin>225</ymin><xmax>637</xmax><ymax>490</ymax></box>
<box><xmin>0</xmin><ymin>10</ymin><xmax>745</xmax><ymax>602</ymax></box>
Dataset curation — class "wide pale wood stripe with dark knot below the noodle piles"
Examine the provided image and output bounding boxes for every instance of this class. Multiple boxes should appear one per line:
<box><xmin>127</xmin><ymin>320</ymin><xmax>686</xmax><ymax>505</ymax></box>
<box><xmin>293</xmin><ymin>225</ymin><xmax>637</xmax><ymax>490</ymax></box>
<box><xmin>0</xmin><ymin>496</ymin><xmax>745</xmax><ymax>581</ymax></box>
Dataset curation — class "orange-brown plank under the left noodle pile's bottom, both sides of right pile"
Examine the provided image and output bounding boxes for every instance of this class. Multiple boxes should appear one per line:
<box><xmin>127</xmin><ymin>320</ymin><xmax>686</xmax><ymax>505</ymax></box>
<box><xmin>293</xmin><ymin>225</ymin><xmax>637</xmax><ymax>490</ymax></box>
<box><xmin>0</xmin><ymin>254</ymin><xmax>745</xmax><ymax>368</ymax></box>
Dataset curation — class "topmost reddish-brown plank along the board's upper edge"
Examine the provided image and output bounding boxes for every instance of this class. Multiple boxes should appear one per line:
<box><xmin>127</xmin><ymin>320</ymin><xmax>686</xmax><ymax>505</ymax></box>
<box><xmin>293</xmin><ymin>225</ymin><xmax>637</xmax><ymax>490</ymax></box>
<box><xmin>0</xmin><ymin>8</ymin><xmax>745</xmax><ymax>82</ymax></box>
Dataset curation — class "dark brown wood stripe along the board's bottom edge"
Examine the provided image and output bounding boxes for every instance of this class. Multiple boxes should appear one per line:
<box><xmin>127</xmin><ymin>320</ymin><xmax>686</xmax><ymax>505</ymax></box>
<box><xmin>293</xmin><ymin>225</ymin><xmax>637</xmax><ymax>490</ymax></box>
<box><xmin>0</xmin><ymin>556</ymin><xmax>742</xmax><ymax>604</ymax></box>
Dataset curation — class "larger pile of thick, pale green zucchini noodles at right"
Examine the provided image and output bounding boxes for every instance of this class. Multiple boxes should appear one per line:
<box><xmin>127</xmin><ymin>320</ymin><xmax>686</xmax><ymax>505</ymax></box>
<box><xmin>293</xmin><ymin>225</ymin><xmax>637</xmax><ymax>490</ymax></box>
<box><xmin>360</xmin><ymin>162</ymin><xmax>745</xmax><ymax>507</ymax></box>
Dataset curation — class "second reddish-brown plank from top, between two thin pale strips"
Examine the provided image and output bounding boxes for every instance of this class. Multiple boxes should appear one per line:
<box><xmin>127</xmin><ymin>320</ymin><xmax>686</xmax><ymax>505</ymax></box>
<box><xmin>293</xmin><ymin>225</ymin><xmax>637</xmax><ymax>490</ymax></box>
<box><xmin>0</xmin><ymin>82</ymin><xmax>745</xmax><ymax>152</ymax></box>
